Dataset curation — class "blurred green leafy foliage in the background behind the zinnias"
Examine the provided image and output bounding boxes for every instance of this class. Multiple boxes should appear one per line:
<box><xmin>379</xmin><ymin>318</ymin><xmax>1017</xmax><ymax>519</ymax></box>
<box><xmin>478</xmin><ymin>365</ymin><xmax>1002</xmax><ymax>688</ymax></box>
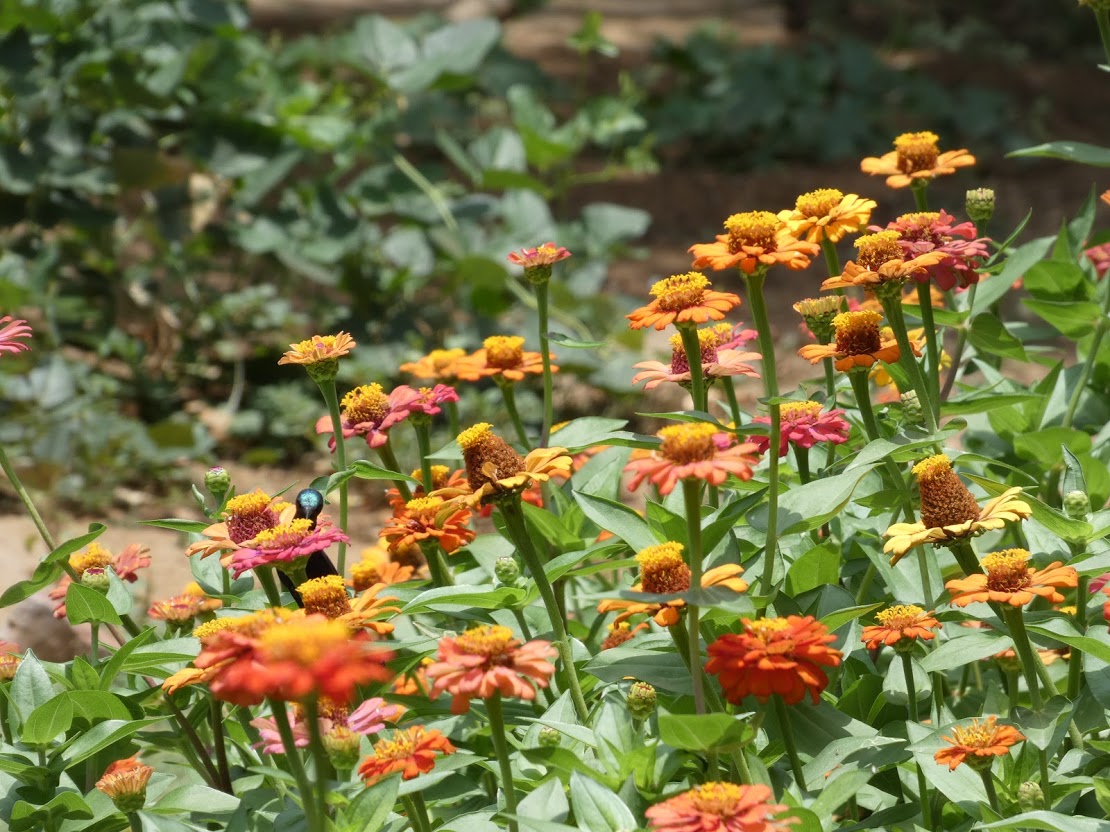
<box><xmin>0</xmin><ymin>0</ymin><xmax>1097</xmax><ymax>508</ymax></box>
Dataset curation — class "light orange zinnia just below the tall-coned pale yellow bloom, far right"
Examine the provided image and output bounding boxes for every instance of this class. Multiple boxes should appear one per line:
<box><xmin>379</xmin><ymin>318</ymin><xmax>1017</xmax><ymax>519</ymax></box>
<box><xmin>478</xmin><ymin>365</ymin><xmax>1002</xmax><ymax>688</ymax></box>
<box><xmin>945</xmin><ymin>549</ymin><xmax>1079</xmax><ymax>607</ymax></box>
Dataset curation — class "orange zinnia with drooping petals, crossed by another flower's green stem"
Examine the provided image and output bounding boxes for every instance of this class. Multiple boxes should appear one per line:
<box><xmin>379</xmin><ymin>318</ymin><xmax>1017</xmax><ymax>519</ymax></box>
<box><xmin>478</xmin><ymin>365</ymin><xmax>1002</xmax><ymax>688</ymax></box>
<box><xmin>597</xmin><ymin>541</ymin><xmax>748</xmax><ymax>638</ymax></box>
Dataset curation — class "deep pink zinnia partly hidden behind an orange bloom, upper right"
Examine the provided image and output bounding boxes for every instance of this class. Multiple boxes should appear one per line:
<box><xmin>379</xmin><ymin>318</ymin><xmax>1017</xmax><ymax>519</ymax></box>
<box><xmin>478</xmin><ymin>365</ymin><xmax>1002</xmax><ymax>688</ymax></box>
<box><xmin>869</xmin><ymin>211</ymin><xmax>990</xmax><ymax>292</ymax></box>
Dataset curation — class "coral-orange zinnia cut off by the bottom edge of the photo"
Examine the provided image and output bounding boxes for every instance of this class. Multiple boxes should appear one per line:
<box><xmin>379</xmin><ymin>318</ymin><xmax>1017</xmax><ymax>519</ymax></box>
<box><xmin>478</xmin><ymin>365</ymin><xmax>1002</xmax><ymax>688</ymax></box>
<box><xmin>644</xmin><ymin>782</ymin><xmax>798</xmax><ymax>832</ymax></box>
